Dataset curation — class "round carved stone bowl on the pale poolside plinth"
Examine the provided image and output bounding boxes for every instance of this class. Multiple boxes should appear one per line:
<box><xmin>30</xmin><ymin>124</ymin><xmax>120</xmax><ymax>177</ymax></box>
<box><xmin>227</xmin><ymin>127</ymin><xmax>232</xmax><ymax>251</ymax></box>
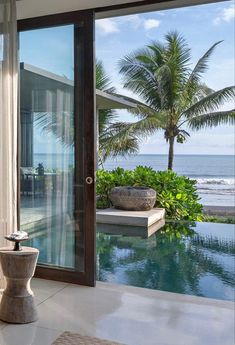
<box><xmin>109</xmin><ymin>186</ymin><xmax>156</xmax><ymax>211</ymax></box>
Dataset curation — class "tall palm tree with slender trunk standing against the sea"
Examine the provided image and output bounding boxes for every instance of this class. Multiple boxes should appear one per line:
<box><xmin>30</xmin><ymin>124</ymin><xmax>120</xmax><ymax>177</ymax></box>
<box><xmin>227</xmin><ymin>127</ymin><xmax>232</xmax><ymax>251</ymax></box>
<box><xmin>119</xmin><ymin>32</ymin><xmax>235</xmax><ymax>170</ymax></box>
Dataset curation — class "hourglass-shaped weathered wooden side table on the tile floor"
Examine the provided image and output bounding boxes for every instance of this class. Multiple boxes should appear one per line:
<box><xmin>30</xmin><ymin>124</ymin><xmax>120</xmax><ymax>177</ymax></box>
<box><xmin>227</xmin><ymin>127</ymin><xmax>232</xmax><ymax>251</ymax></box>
<box><xmin>0</xmin><ymin>247</ymin><xmax>39</xmax><ymax>323</ymax></box>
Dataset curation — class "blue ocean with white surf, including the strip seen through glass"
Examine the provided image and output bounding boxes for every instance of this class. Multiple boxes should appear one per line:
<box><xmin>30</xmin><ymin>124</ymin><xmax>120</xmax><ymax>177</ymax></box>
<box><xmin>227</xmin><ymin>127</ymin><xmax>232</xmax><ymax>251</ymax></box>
<box><xmin>34</xmin><ymin>154</ymin><xmax>235</xmax><ymax>206</ymax></box>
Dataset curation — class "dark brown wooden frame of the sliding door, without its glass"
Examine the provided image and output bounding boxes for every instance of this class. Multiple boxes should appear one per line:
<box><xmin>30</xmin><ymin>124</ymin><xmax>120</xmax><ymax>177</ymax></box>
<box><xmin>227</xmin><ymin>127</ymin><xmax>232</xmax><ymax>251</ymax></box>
<box><xmin>18</xmin><ymin>10</ymin><xmax>96</xmax><ymax>286</ymax></box>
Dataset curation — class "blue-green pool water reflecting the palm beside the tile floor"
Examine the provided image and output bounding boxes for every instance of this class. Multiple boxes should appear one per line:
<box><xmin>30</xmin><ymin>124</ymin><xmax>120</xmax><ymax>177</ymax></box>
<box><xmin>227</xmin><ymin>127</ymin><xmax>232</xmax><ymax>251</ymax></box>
<box><xmin>97</xmin><ymin>223</ymin><xmax>235</xmax><ymax>300</ymax></box>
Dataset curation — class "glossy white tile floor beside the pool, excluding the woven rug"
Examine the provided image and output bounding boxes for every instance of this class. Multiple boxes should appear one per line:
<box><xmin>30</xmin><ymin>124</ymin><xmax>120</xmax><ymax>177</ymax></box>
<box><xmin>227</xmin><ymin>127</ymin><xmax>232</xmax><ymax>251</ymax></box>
<box><xmin>0</xmin><ymin>279</ymin><xmax>234</xmax><ymax>345</ymax></box>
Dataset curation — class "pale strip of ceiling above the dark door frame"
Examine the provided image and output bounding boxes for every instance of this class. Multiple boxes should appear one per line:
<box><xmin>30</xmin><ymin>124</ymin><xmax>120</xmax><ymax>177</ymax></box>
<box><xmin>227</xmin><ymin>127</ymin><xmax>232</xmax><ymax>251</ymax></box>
<box><xmin>17</xmin><ymin>0</ymin><xmax>143</xmax><ymax>19</ymax></box>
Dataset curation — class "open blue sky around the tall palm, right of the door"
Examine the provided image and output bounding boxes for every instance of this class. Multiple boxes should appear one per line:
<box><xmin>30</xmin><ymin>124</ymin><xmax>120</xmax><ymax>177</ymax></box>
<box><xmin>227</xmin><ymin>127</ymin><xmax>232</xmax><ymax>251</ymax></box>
<box><xmin>96</xmin><ymin>1</ymin><xmax>235</xmax><ymax>154</ymax></box>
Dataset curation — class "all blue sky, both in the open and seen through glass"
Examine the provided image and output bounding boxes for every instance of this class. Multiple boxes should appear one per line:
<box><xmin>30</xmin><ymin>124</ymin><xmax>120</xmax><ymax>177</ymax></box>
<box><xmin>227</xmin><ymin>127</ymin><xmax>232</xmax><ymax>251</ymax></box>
<box><xmin>20</xmin><ymin>1</ymin><xmax>235</xmax><ymax>154</ymax></box>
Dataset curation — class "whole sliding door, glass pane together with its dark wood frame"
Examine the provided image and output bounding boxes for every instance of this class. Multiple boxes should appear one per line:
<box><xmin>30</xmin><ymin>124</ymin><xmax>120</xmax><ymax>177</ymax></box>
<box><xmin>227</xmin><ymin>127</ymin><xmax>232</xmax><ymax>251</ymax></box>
<box><xmin>19</xmin><ymin>14</ymin><xmax>95</xmax><ymax>285</ymax></box>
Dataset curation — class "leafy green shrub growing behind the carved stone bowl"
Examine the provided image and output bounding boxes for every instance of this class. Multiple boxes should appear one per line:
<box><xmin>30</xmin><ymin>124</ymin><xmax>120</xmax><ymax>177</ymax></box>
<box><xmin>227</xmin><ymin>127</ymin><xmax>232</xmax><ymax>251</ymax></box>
<box><xmin>97</xmin><ymin>166</ymin><xmax>202</xmax><ymax>221</ymax></box>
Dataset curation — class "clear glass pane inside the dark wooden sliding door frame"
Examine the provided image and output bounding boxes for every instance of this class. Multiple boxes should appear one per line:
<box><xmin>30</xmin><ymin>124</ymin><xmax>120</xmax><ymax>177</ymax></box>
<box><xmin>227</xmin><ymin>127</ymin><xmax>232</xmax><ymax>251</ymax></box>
<box><xmin>20</xmin><ymin>25</ymin><xmax>84</xmax><ymax>271</ymax></box>
